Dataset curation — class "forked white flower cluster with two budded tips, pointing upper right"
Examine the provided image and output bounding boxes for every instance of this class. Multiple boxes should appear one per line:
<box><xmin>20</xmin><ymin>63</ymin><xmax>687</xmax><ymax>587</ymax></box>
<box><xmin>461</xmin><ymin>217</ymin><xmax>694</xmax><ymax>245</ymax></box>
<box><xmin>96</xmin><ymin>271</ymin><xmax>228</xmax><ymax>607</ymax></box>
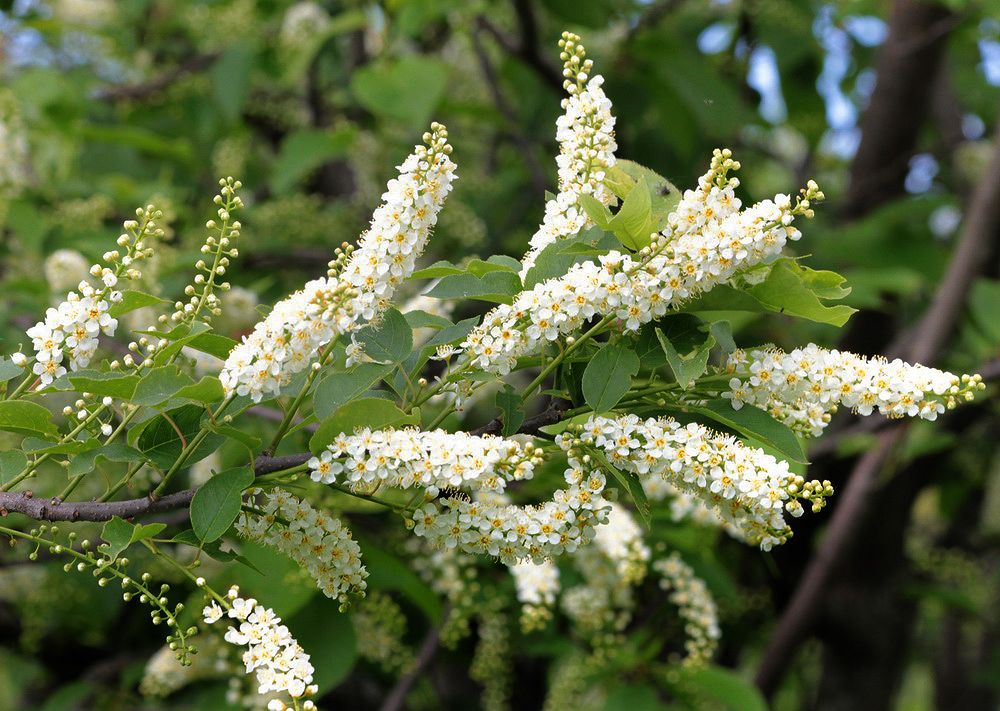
<box><xmin>462</xmin><ymin>150</ymin><xmax>822</xmax><ymax>375</ymax></box>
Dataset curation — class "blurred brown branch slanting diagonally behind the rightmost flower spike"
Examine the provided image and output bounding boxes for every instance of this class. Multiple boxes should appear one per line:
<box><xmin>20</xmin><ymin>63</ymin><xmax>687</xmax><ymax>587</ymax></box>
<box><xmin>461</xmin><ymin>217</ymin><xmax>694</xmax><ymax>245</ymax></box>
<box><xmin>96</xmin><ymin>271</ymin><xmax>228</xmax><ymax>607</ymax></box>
<box><xmin>756</xmin><ymin>121</ymin><xmax>1000</xmax><ymax>696</ymax></box>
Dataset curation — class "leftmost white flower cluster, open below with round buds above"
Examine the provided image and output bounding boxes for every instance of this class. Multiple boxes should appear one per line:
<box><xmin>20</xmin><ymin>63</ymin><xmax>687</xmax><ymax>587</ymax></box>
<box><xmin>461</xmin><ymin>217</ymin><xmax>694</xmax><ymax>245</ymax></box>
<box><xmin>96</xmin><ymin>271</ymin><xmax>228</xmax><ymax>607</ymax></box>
<box><xmin>18</xmin><ymin>205</ymin><xmax>159</xmax><ymax>385</ymax></box>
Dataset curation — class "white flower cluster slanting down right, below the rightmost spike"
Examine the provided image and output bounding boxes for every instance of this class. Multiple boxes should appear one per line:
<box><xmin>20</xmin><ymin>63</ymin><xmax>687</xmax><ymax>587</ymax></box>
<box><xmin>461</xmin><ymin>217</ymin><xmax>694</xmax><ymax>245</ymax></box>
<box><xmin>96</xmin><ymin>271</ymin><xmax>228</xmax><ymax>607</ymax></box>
<box><xmin>580</xmin><ymin>415</ymin><xmax>833</xmax><ymax>550</ymax></box>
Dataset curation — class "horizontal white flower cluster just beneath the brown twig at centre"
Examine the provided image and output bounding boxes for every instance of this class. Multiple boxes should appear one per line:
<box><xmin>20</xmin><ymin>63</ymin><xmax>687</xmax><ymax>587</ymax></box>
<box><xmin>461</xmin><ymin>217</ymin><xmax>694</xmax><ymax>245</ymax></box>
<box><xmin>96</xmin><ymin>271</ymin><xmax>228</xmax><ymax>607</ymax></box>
<box><xmin>309</xmin><ymin>428</ymin><xmax>541</xmax><ymax>496</ymax></box>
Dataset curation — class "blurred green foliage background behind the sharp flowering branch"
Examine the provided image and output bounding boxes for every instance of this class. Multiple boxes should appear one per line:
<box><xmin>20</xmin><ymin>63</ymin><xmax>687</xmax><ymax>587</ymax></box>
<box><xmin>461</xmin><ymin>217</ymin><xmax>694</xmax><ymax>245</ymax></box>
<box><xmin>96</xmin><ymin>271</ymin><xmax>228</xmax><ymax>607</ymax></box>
<box><xmin>0</xmin><ymin>0</ymin><xmax>1000</xmax><ymax>711</ymax></box>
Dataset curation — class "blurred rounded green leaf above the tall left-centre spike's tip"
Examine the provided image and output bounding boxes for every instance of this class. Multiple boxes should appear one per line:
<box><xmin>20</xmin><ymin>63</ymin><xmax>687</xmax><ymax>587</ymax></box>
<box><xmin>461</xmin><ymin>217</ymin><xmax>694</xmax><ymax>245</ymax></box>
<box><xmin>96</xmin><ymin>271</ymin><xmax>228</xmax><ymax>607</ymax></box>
<box><xmin>351</xmin><ymin>56</ymin><xmax>448</xmax><ymax>130</ymax></box>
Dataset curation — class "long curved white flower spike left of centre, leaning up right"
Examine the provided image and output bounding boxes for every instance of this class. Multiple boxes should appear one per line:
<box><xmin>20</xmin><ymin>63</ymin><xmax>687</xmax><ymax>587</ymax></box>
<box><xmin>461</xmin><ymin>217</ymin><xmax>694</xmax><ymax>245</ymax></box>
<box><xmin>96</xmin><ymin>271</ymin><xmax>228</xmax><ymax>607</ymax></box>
<box><xmin>219</xmin><ymin>123</ymin><xmax>455</xmax><ymax>402</ymax></box>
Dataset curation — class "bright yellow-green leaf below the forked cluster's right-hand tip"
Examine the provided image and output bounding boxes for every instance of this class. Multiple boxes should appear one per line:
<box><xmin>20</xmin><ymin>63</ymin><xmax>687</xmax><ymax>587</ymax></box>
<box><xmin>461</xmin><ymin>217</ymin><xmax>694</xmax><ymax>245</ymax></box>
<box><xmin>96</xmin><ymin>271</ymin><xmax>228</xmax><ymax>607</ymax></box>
<box><xmin>748</xmin><ymin>259</ymin><xmax>857</xmax><ymax>326</ymax></box>
